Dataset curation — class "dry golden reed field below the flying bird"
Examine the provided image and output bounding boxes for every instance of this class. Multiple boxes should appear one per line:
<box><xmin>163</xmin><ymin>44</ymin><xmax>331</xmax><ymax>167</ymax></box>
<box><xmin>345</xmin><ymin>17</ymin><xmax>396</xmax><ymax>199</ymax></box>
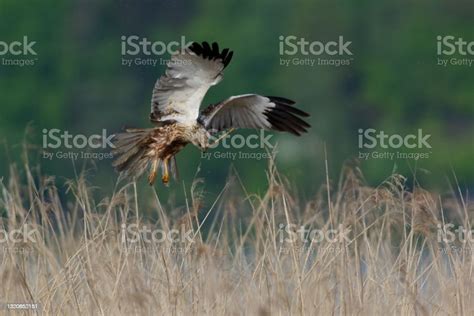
<box><xmin>0</xmin><ymin>158</ymin><xmax>474</xmax><ymax>315</ymax></box>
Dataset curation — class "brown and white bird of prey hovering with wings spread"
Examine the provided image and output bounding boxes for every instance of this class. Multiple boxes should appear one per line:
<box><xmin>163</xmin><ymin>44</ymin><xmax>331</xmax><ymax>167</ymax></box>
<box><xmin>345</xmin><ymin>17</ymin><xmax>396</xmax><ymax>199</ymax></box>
<box><xmin>113</xmin><ymin>42</ymin><xmax>310</xmax><ymax>185</ymax></box>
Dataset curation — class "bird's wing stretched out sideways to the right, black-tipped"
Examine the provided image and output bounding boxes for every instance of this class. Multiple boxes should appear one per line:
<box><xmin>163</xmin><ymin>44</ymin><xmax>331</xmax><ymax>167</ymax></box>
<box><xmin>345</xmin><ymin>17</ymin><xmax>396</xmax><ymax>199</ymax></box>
<box><xmin>199</xmin><ymin>94</ymin><xmax>311</xmax><ymax>136</ymax></box>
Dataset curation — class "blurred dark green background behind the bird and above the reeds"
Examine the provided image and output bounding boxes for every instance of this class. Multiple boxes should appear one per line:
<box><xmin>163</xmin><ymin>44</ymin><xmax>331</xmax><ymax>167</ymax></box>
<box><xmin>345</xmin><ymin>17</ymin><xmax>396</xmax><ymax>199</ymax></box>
<box><xmin>0</xmin><ymin>0</ymin><xmax>474</xmax><ymax>200</ymax></box>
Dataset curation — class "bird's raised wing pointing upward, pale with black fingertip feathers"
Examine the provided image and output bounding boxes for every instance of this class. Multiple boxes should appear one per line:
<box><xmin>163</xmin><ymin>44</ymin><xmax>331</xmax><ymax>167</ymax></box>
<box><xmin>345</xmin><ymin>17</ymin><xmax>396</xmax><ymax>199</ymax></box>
<box><xmin>150</xmin><ymin>42</ymin><xmax>233</xmax><ymax>124</ymax></box>
